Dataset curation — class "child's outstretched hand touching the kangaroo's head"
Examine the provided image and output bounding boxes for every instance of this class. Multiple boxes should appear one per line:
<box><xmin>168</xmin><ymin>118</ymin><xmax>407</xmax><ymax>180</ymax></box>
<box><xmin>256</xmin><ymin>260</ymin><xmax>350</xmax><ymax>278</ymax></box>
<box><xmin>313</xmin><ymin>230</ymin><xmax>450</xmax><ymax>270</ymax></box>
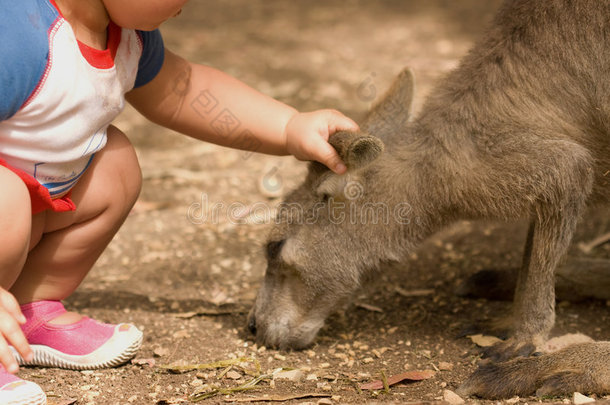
<box><xmin>285</xmin><ymin>110</ymin><xmax>358</xmax><ymax>174</ymax></box>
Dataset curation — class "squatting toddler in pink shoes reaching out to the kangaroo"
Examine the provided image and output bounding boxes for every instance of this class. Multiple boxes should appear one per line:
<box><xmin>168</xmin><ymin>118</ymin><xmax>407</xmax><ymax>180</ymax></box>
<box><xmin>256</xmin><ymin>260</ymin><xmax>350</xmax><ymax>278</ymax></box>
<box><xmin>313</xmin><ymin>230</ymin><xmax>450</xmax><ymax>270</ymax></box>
<box><xmin>0</xmin><ymin>0</ymin><xmax>357</xmax><ymax>404</ymax></box>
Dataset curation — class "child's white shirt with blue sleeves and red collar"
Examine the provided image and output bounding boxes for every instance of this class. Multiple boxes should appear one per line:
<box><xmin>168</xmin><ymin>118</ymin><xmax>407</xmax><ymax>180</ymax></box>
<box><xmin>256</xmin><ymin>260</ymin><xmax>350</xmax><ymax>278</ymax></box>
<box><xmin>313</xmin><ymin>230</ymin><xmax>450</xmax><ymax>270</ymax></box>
<box><xmin>0</xmin><ymin>0</ymin><xmax>164</xmax><ymax>198</ymax></box>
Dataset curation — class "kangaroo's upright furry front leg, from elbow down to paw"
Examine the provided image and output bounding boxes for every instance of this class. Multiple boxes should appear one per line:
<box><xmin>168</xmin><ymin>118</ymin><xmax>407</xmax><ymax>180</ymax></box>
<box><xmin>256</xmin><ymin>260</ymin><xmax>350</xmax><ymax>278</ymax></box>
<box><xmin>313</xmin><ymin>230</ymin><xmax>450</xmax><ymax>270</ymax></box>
<box><xmin>487</xmin><ymin>141</ymin><xmax>592</xmax><ymax>361</ymax></box>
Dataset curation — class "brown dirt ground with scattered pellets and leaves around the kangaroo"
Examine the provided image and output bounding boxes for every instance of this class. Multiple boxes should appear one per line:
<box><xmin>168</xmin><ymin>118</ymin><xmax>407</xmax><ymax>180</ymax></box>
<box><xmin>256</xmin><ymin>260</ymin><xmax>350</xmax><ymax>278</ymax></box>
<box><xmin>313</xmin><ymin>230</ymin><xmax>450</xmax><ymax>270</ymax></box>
<box><xmin>21</xmin><ymin>0</ymin><xmax>610</xmax><ymax>404</ymax></box>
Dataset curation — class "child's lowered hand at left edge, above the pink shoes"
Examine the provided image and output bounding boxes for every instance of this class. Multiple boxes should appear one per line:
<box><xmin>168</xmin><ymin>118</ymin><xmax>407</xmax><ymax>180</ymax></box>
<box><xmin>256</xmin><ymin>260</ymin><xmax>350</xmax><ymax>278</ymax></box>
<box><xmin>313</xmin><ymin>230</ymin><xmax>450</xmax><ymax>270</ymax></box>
<box><xmin>0</xmin><ymin>288</ymin><xmax>33</xmax><ymax>373</ymax></box>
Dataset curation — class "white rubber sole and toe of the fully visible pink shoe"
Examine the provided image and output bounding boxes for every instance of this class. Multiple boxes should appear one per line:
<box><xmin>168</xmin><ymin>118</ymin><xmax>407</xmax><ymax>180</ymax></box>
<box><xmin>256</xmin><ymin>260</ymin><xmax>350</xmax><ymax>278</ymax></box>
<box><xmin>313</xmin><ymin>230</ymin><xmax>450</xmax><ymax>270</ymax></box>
<box><xmin>11</xmin><ymin>325</ymin><xmax>142</xmax><ymax>370</ymax></box>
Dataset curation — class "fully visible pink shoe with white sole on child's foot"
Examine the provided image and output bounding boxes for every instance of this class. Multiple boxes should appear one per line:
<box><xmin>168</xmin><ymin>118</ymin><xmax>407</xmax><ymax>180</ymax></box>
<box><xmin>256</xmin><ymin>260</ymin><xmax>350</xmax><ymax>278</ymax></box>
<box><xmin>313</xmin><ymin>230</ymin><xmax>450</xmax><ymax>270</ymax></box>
<box><xmin>13</xmin><ymin>301</ymin><xmax>142</xmax><ymax>370</ymax></box>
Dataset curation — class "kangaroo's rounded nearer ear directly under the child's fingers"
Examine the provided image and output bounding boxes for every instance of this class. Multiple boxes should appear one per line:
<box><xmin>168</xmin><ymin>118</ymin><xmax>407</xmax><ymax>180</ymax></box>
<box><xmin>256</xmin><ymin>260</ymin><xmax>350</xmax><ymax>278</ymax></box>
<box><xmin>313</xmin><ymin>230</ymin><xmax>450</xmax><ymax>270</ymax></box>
<box><xmin>328</xmin><ymin>131</ymin><xmax>384</xmax><ymax>170</ymax></box>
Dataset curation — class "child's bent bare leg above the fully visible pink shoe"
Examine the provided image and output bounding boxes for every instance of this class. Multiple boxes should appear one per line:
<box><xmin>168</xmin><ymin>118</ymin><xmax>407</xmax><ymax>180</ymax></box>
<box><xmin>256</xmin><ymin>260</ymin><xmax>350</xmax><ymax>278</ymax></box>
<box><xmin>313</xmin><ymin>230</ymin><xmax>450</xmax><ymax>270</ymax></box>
<box><xmin>11</xmin><ymin>127</ymin><xmax>141</xmax><ymax>323</ymax></box>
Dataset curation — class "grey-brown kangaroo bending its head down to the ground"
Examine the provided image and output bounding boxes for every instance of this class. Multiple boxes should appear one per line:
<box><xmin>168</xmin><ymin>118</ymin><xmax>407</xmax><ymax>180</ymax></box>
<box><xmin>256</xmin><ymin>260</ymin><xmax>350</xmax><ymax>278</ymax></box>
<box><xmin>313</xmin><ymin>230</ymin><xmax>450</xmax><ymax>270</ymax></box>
<box><xmin>248</xmin><ymin>0</ymin><xmax>610</xmax><ymax>397</ymax></box>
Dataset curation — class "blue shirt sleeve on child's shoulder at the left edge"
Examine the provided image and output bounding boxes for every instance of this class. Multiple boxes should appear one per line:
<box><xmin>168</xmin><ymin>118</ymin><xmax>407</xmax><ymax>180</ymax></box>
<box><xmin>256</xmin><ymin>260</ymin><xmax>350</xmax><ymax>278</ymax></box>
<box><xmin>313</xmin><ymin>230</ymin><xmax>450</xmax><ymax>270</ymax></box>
<box><xmin>0</xmin><ymin>0</ymin><xmax>57</xmax><ymax>121</ymax></box>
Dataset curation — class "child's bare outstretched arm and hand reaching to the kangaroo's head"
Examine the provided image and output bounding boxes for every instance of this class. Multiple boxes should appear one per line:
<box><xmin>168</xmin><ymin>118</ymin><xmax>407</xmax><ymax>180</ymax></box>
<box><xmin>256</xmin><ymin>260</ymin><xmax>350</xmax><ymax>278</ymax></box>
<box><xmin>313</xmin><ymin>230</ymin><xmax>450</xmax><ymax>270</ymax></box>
<box><xmin>127</xmin><ymin>50</ymin><xmax>358</xmax><ymax>173</ymax></box>
